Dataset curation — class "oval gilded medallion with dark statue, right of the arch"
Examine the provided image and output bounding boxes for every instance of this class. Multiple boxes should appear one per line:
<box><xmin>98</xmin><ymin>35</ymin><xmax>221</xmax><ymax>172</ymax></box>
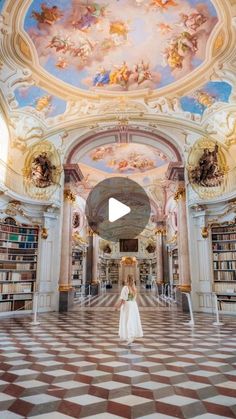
<box><xmin>188</xmin><ymin>138</ymin><xmax>228</xmax><ymax>199</ymax></box>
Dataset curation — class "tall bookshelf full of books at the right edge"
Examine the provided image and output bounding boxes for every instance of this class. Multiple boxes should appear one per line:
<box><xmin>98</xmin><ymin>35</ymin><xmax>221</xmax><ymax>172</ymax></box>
<box><xmin>211</xmin><ymin>223</ymin><xmax>236</xmax><ymax>311</ymax></box>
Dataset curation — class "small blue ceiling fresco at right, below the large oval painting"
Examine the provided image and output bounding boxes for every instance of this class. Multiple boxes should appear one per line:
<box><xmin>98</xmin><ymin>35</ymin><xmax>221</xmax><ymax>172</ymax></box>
<box><xmin>180</xmin><ymin>81</ymin><xmax>232</xmax><ymax>115</ymax></box>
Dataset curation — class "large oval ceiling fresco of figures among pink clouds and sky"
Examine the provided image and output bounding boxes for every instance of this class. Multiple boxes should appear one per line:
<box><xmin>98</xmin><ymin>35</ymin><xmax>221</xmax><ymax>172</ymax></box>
<box><xmin>24</xmin><ymin>0</ymin><xmax>218</xmax><ymax>92</ymax></box>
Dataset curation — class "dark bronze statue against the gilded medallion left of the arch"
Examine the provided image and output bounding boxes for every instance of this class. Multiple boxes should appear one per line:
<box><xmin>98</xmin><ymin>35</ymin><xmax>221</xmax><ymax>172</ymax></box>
<box><xmin>30</xmin><ymin>152</ymin><xmax>56</xmax><ymax>188</ymax></box>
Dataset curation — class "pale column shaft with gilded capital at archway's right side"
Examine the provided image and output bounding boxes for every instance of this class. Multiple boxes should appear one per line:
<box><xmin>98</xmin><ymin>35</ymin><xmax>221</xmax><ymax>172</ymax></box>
<box><xmin>175</xmin><ymin>186</ymin><xmax>191</xmax><ymax>292</ymax></box>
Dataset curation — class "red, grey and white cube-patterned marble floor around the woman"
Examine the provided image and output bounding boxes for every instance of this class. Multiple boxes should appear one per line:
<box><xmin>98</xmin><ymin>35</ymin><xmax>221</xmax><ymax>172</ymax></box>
<box><xmin>0</xmin><ymin>294</ymin><xmax>236</xmax><ymax>419</ymax></box>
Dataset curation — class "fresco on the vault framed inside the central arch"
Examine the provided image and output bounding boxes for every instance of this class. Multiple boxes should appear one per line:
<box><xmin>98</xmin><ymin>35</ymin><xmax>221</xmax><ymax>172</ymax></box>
<box><xmin>79</xmin><ymin>143</ymin><xmax>168</xmax><ymax>175</ymax></box>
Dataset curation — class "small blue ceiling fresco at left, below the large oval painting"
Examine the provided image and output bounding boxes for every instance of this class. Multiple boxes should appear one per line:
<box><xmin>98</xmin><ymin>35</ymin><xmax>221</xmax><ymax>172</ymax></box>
<box><xmin>14</xmin><ymin>86</ymin><xmax>66</xmax><ymax>118</ymax></box>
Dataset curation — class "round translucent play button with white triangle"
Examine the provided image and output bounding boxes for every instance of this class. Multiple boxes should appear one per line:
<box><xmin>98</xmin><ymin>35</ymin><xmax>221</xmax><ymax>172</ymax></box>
<box><xmin>85</xmin><ymin>177</ymin><xmax>151</xmax><ymax>242</ymax></box>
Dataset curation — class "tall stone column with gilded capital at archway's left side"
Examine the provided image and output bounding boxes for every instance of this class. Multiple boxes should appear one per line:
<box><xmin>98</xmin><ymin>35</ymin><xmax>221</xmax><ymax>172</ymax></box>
<box><xmin>59</xmin><ymin>184</ymin><xmax>76</xmax><ymax>312</ymax></box>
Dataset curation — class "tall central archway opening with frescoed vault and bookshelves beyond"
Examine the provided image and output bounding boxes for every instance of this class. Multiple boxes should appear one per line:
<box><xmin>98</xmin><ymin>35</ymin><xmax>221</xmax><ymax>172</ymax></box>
<box><xmin>65</xmin><ymin>129</ymin><xmax>182</xmax><ymax>298</ymax></box>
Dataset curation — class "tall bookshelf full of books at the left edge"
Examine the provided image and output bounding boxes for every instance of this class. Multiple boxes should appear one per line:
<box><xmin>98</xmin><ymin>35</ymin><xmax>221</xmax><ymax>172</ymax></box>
<box><xmin>0</xmin><ymin>217</ymin><xmax>38</xmax><ymax>312</ymax></box>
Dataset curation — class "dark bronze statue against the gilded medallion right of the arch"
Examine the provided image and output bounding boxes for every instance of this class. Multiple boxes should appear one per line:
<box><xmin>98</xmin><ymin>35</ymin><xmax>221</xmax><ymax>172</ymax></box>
<box><xmin>190</xmin><ymin>144</ymin><xmax>224</xmax><ymax>187</ymax></box>
